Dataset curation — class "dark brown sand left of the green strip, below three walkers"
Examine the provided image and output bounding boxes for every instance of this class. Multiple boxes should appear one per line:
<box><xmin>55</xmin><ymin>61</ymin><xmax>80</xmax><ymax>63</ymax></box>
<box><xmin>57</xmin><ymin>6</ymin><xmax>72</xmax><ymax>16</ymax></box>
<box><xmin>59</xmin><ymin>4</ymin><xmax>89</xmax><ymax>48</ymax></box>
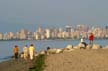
<box><xmin>0</xmin><ymin>59</ymin><xmax>32</xmax><ymax>71</ymax></box>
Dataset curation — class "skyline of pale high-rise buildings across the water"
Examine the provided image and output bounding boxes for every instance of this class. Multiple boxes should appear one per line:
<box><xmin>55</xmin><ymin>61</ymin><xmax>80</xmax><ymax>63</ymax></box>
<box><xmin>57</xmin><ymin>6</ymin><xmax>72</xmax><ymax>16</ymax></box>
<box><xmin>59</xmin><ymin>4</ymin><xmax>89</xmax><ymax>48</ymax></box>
<box><xmin>0</xmin><ymin>25</ymin><xmax>108</xmax><ymax>40</ymax></box>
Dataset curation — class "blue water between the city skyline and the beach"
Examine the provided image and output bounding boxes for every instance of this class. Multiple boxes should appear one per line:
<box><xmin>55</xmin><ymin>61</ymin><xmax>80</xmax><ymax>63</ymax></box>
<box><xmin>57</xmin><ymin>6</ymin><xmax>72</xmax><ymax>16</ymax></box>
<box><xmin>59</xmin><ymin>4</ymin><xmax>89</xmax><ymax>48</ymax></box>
<box><xmin>0</xmin><ymin>39</ymin><xmax>108</xmax><ymax>62</ymax></box>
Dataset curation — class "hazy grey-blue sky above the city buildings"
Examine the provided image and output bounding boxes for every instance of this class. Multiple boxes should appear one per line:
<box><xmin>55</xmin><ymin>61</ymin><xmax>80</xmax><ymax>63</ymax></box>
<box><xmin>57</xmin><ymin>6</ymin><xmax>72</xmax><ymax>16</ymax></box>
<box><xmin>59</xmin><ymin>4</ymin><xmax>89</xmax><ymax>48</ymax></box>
<box><xmin>0</xmin><ymin>0</ymin><xmax>108</xmax><ymax>32</ymax></box>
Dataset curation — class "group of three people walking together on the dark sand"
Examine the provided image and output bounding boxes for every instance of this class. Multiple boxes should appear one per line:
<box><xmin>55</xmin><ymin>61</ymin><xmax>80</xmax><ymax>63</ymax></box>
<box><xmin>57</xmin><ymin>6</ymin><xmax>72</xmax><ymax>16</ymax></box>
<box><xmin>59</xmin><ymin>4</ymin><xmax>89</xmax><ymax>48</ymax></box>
<box><xmin>13</xmin><ymin>44</ymin><xmax>35</xmax><ymax>60</ymax></box>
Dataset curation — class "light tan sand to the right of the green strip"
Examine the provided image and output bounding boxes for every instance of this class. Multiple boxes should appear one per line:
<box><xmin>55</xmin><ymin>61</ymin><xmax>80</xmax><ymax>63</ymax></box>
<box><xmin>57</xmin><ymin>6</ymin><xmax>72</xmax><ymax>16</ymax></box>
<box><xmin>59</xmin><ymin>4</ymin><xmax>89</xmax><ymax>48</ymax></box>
<box><xmin>44</xmin><ymin>49</ymin><xmax>108</xmax><ymax>71</ymax></box>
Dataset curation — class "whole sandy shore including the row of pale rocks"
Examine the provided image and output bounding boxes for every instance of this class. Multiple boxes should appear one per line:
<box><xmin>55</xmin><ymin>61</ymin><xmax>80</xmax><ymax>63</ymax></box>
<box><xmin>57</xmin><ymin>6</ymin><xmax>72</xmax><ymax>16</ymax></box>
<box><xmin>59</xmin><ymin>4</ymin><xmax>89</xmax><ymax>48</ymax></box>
<box><xmin>0</xmin><ymin>44</ymin><xmax>108</xmax><ymax>71</ymax></box>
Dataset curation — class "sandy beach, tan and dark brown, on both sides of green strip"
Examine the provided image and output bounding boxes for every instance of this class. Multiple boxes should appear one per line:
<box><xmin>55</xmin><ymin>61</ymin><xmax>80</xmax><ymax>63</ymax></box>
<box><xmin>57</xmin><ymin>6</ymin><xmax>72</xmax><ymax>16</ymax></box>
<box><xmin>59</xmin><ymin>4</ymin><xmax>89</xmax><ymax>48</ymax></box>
<box><xmin>0</xmin><ymin>49</ymin><xmax>108</xmax><ymax>71</ymax></box>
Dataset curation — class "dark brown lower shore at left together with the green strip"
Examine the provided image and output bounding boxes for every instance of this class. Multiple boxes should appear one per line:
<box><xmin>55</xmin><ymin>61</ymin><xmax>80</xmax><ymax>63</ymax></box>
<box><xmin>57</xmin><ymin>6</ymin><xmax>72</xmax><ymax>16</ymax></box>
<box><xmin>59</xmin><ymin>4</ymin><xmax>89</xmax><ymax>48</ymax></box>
<box><xmin>0</xmin><ymin>55</ymin><xmax>45</xmax><ymax>71</ymax></box>
